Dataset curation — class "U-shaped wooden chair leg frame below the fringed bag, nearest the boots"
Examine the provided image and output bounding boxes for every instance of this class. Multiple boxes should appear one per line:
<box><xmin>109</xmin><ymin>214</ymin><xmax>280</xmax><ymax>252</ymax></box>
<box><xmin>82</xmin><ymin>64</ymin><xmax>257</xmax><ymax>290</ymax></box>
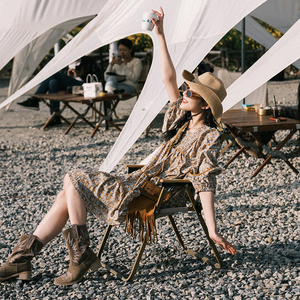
<box><xmin>98</xmin><ymin>225</ymin><xmax>147</xmax><ymax>281</ymax></box>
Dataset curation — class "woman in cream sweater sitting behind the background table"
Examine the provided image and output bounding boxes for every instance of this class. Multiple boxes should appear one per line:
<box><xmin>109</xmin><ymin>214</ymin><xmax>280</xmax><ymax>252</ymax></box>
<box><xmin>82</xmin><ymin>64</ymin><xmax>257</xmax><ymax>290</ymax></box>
<box><xmin>105</xmin><ymin>39</ymin><xmax>142</xmax><ymax>95</ymax></box>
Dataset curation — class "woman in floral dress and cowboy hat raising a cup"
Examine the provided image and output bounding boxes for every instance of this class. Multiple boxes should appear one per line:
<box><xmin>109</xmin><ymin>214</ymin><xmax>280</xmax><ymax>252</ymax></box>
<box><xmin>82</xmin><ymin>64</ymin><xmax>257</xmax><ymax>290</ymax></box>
<box><xmin>0</xmin><ymin>9</ymin><xmax>236</xmax><ymax>285</ymax></box>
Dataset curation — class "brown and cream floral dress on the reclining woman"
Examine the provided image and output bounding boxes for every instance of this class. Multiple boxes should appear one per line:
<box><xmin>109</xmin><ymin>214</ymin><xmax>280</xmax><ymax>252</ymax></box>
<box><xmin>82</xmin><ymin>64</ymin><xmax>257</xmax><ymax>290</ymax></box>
<box><xmin>69</xmin><ymin>98</ymin><xmax>221</xmax><ymax>225</ymax></box>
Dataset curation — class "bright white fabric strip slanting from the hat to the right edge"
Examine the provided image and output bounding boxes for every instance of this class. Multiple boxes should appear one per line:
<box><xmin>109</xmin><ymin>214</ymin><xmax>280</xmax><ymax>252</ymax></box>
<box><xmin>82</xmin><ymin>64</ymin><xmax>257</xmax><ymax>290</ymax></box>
<box><xmin>223</xmin><ymin>20</ymin><xmax>300</xmax><ymax>111</ymax></box>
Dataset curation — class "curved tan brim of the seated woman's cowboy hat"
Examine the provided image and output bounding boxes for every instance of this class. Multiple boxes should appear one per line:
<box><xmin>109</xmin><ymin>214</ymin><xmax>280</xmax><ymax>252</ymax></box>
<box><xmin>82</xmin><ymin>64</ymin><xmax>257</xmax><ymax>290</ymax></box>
<box><xmin>182</xmin><ymin>70</ymin><xmax>223</xmax><ymax>123</ymax></box>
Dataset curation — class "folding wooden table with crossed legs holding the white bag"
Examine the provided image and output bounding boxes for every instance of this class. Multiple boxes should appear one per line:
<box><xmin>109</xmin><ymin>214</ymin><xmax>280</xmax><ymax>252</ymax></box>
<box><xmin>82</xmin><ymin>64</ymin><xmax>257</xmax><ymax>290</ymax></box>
<box><xmin>34</xmin><ymin>93</ymin><xmax>131</xmax><ymax>137</ymax></box>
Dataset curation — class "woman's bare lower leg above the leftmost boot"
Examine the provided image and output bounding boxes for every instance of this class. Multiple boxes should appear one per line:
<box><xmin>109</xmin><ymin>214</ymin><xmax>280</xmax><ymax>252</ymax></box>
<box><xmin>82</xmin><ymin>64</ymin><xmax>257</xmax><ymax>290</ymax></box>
<box><xmin>33</xmin><ymin>191</ymin><xmax>69</xmax><ymax>245</ymax></box>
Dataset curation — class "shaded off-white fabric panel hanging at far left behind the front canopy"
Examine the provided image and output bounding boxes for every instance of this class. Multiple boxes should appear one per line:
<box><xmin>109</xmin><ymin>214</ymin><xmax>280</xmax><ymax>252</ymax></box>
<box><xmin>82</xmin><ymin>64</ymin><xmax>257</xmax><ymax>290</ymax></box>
<box><xmin>8</xmin><ymin>16</ymin><xmax>93</xmax><ymax>96</ymax></box>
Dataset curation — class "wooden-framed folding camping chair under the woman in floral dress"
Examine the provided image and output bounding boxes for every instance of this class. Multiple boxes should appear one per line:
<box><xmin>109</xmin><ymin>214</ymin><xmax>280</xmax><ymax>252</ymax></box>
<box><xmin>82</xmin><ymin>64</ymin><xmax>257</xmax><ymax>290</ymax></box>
<box><xmin>98</xmin><ymin>165</ymin><xmax>223</xmax><ymax>281</ymax></box>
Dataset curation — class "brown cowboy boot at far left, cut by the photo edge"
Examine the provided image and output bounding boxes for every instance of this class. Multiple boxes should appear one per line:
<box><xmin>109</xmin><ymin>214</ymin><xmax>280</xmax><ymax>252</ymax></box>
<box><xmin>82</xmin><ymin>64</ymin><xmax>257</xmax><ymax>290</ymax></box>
<box><xmin>0</xmin><ymin>234</ymin><xmax>44</xmax><ymax>281</ymax></box>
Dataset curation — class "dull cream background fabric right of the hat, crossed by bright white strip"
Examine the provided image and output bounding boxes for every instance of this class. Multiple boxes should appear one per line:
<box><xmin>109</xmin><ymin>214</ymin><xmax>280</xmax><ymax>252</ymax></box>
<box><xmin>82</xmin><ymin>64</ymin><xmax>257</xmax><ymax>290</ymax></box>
<box><xmin>214</xmin><ymin>67</ymin><xmax>267</xmax><ymax>109</ymax></box>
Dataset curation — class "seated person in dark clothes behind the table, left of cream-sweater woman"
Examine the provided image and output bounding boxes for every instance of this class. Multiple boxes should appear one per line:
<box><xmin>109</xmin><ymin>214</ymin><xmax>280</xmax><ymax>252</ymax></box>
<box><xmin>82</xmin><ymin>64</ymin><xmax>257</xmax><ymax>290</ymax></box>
<box><xmin>17</xmin><ymin>56</ymin><xmax>100</xmax><ymax>126</ymax></box>
